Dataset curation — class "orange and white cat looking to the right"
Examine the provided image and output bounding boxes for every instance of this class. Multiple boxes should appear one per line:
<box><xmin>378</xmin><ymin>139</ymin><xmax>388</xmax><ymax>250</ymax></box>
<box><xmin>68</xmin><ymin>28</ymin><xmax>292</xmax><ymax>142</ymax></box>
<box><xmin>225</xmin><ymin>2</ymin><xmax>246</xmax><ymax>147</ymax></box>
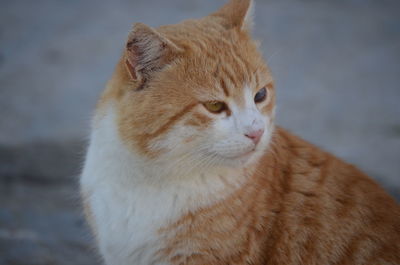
<box><xmin>80</xmin><ymin>0</ymin><xmax>400</xmax><ymax>265</ymax></box>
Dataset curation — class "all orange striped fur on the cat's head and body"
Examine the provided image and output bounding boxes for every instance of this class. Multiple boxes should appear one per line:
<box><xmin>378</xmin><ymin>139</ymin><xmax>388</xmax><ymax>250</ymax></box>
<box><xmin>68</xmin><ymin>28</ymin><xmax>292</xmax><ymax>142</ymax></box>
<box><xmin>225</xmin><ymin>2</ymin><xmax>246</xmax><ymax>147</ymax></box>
<box><xmin>83</xmin><ymin>0</ymin><xmax>400</xmax><ymax>265</ymax></box>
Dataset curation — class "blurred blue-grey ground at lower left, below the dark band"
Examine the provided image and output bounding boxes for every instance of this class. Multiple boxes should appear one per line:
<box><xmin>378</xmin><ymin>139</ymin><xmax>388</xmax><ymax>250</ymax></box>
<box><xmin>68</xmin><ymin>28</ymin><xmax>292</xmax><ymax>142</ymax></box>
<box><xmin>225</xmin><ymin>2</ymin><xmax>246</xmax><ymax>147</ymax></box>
<box><xmin>0</xmin><ymin>182</ymin><xmax>100</xmax><ymax>265</ymax></box>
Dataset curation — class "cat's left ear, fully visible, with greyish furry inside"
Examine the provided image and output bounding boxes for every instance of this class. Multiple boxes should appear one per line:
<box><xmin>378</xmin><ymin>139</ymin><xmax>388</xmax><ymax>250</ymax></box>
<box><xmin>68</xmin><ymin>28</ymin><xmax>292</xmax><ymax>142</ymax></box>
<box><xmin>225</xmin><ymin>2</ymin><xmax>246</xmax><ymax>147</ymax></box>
<box><xmin>125</xmin><ymin>23</ymin><xmax>180</xmax><ymax>81</ymax></box>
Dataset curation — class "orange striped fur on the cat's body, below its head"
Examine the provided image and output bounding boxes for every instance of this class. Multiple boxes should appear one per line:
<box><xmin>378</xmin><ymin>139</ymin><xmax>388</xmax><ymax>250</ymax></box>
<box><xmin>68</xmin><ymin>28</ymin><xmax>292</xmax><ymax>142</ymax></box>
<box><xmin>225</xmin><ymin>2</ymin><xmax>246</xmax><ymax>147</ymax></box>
<box><xmin>156</xmin><ymin>128</ymin><xmax>400</xmax><ymax>265</ymax></box>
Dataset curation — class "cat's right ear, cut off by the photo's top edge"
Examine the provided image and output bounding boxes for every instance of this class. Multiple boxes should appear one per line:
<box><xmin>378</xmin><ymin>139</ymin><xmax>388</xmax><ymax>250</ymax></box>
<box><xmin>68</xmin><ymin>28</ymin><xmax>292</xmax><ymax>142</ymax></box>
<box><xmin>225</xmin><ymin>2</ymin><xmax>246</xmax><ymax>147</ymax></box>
<box><xmin>211</xmin><ymin>0</ymin><xmax>254</xmax><ymax>30</ymax></box>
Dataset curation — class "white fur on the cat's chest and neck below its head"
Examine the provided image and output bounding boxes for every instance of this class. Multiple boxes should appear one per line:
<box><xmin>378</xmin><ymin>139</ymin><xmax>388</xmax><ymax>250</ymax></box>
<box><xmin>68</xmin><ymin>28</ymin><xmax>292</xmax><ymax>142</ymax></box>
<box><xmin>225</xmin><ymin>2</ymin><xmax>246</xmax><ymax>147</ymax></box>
<box><xmin>81</xmin><ymin>105</ymin><xmax>245</xmax><ymax>265</ymax></box>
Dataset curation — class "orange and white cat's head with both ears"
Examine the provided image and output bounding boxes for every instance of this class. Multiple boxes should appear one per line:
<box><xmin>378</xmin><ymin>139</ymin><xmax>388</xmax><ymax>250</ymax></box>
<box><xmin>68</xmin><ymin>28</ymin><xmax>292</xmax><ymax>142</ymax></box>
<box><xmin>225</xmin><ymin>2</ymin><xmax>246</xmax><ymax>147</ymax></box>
<box><xmin>103</xmin><ymin>0</ymin><xmax>275</xmax><ymax>171</ymax></box>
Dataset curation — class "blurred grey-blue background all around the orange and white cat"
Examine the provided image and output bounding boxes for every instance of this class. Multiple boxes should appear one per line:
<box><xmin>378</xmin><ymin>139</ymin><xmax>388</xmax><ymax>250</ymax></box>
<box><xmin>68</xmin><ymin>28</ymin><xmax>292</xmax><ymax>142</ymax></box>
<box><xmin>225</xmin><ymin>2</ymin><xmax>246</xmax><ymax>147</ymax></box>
<box><xmin>0</xmin><ymin>0</ymin><xmax>400</xmax><ymax>265</ymax></box>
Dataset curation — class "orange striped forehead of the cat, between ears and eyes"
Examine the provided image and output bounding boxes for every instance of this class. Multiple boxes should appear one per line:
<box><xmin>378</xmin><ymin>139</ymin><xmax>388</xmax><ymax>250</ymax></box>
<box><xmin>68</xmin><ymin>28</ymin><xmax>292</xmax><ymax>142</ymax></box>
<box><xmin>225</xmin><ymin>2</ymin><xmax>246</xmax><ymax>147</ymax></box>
<box><xmin>159</xmin><ymin>24</ymin><xmax>272</xmax><ymax>101</ymax></box>
